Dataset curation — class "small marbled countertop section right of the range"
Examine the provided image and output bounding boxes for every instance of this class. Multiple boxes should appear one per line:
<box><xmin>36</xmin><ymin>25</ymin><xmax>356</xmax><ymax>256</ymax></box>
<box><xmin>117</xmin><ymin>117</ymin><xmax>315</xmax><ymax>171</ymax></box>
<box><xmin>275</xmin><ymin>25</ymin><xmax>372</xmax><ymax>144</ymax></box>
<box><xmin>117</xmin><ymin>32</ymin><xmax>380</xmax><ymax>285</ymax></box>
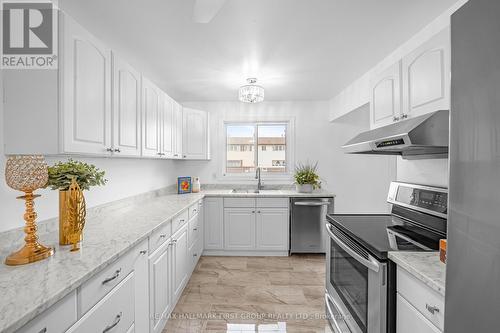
<box><xmin>389</xmin><ymin>252</ymin><xmax>446</xmax><ymax>297</ymax></box>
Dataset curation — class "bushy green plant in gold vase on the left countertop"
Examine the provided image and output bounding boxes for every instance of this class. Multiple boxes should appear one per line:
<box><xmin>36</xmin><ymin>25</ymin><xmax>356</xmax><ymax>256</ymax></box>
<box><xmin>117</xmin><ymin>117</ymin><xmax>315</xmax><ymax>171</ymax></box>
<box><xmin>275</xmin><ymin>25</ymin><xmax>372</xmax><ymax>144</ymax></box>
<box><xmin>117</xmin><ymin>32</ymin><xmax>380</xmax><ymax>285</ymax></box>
<box><xmin>47</xmin><ymin>159</ymin><xmax>107</xmax><ymax>245</ymax></box>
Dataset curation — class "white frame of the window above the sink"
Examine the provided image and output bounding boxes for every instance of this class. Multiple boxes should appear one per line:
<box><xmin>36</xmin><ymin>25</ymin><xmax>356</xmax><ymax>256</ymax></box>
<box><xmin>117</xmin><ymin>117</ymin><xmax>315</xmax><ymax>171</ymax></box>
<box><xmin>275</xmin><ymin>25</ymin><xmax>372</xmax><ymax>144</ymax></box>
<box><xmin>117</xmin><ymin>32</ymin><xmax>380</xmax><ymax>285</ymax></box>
<box><xmin>218</xmin><ymin>115</ymin><xmax>295</xmax><ymax>182</ymax></box>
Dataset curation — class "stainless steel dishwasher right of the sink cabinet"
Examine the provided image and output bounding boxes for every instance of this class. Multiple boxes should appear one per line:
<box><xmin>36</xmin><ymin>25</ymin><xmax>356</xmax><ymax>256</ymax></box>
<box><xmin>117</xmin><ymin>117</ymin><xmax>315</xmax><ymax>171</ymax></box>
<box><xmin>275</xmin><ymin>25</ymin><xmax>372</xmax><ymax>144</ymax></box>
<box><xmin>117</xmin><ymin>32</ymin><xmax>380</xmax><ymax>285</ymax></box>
<box><xmin>290</xmin><ymin>198</ymin><xmax>333</xmax><ymax>254</ymax></box>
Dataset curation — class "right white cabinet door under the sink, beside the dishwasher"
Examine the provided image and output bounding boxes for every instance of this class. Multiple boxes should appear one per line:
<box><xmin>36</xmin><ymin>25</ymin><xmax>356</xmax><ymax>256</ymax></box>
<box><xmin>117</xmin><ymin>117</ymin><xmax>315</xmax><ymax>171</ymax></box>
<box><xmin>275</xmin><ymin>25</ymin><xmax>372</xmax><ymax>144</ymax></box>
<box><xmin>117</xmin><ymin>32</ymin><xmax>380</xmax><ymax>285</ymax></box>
<box><xmin>256</xmin><ymin>208</ymin><xmax>289</xmax><ymax>251</ymax></box>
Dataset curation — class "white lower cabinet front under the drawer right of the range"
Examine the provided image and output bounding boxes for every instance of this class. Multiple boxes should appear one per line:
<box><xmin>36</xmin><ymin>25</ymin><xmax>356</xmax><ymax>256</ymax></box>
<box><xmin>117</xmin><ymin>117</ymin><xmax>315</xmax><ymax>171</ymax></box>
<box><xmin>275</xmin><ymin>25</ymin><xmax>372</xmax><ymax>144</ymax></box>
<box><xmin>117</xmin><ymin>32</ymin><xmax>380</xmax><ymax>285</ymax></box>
<box><xmin>396</xmin><ymin>294</ymin><xmax>441</xmax><ymax>333</ymax></box>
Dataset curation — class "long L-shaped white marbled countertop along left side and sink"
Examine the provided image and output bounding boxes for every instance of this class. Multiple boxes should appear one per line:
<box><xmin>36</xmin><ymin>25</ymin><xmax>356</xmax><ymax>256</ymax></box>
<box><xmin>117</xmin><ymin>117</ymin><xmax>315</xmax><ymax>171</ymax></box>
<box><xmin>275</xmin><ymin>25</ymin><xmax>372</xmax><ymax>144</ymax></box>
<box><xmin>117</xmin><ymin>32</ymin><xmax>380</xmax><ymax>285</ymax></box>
<box><xmin>0</xmin><ymin>189</ymin><xmax>334</xmax><ymax>333</ymax></box>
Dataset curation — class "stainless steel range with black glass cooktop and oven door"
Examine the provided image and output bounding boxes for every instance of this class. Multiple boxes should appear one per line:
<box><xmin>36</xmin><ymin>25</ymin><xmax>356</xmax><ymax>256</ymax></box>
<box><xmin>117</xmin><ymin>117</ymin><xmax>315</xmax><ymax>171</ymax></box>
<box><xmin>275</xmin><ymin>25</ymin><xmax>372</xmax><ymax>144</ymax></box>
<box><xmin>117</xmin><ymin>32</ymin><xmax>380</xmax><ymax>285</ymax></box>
<box><xmin>325</xmin><ymin>182</ymin><xmax>448</xmax><ymax>333</ymax></box>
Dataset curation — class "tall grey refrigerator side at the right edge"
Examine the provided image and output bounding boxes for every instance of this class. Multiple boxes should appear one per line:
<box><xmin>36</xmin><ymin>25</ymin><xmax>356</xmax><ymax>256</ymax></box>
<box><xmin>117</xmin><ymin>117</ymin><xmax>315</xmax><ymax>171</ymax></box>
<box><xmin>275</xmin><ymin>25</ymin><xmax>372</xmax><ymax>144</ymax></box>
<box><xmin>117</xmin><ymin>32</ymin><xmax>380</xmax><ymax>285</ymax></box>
<box><xmin>445</xmin><ymin>0</ymin><xmax>500</xmax><ymax>333</ymax></box>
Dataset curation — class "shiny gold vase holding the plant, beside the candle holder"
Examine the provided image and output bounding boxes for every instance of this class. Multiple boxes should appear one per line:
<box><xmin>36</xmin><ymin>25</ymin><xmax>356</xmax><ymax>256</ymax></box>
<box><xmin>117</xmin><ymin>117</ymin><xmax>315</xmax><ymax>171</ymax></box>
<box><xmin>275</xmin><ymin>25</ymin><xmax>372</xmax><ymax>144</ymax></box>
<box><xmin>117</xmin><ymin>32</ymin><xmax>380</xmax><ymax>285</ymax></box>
<box><xmin>59</xmin><ymin>187</ymin><xmax>86</xmax><ymax>249</ymax></box>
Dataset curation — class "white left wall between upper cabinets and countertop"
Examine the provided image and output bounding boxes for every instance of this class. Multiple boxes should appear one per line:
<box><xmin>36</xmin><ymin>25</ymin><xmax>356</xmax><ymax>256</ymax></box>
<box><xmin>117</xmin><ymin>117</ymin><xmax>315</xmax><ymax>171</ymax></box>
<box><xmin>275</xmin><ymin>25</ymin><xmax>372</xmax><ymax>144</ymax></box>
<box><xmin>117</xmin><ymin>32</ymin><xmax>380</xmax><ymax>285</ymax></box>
<box><xmin>0</xmin><ymin>70</ymin><xmax>182</xmax><ymax>232</ymax></box>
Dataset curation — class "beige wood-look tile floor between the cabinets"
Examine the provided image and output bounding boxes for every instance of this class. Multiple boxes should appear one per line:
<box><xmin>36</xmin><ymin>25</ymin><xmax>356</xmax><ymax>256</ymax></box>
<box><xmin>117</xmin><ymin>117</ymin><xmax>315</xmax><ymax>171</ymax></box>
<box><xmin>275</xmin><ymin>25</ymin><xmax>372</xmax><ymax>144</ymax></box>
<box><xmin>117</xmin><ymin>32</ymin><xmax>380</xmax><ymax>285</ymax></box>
<box><xmin>163</xmin><ymin>255</ymin><xmax>331</xmax><ymax>333</ymax></box>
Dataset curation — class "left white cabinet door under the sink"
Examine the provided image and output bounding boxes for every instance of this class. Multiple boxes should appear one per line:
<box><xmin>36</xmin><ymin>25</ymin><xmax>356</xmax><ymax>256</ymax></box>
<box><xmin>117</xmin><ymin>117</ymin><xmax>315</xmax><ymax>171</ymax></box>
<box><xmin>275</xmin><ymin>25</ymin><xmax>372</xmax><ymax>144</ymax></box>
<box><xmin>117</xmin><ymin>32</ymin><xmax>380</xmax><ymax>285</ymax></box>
<box><xmin>224</xmin><ymin>208</ymin><xmax>255</xmax><ymax>250</ymax></box>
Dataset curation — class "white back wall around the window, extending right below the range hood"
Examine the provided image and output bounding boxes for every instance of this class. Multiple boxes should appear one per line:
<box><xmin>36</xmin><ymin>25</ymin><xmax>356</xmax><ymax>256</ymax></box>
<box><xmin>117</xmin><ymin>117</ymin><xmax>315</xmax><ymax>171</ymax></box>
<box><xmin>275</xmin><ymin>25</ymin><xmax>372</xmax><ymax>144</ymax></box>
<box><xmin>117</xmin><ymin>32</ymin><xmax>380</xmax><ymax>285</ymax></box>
<box><xmin>179</xmin><ymin>101</ymin><xmax>396</xmax><ymax>213</ymax></box>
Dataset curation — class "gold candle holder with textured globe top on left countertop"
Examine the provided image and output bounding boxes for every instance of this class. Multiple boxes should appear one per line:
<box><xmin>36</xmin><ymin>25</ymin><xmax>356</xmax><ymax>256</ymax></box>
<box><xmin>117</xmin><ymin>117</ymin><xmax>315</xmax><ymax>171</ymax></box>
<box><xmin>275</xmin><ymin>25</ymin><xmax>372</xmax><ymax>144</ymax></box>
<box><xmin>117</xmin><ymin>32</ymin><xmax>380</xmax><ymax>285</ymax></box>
<box><xmin>5</xmin><ymin>155</ymin><xmax>54</xmax><ymax>266</ymax></box>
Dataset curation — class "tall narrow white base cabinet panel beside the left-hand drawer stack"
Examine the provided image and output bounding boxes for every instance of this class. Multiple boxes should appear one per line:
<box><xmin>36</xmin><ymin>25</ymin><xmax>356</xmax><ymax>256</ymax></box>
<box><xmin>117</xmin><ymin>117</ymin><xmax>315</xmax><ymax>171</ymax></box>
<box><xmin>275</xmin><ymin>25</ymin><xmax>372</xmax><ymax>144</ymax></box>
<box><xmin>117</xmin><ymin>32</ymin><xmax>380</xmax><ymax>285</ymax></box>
<box><xmin>132</xmin><ymin>240</ymin><xmax>150</xmax><ymax>332</ymax></box>
